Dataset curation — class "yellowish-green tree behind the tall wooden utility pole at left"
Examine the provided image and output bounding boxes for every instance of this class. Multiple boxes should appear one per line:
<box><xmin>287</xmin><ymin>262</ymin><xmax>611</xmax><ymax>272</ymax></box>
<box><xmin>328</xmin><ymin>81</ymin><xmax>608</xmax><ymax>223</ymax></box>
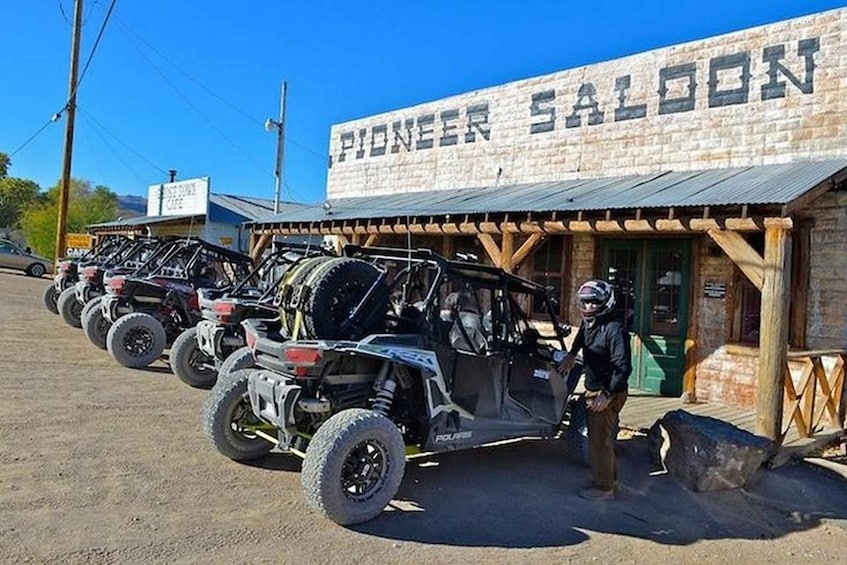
<box><xmin>20</xmin><ymin>179</ymin><xmax>118</xmax><ymax>257</ymax></box>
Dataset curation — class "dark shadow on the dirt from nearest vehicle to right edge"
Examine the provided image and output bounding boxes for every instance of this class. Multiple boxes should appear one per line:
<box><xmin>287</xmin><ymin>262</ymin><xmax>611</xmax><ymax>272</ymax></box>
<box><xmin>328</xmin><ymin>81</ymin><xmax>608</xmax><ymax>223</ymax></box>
<box><xmin>353</xmin><ymin>437</ymin><xmax>847</xmax><ymax>548</ymax></box>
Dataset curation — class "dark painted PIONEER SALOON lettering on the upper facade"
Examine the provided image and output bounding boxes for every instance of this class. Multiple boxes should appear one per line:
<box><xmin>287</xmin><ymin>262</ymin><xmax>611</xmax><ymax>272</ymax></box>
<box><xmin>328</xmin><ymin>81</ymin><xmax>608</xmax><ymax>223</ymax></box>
<box><xmin>329</xmin><ymin>37</ymin><xmax>820</xmax><ymax>167</ymax></box>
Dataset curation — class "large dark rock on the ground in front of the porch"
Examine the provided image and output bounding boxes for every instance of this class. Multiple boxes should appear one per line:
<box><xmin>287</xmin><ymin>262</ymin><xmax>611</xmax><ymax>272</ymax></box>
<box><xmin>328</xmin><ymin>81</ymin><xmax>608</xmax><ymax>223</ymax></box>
<box><xmin>648</xmin><ymin>410</ymin><xmax>773</xmax><ymax>491</ymax></box>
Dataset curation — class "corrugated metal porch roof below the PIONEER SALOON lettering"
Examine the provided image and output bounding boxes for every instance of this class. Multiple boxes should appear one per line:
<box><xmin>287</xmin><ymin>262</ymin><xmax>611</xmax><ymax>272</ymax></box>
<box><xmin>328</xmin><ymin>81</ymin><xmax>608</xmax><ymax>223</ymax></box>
<box><xmin>255</xmin><ymin>159</ymin><xmax>847</xmax><ymax>224</ymax></box>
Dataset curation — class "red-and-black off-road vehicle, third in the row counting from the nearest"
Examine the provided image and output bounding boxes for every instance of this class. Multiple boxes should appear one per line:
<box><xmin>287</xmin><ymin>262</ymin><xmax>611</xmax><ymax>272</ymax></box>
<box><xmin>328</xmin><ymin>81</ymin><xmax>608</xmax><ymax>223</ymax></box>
<box><xmin>101</xmin><ymin>239</ymin><xmax>253</xmax><ymax>368</ymax></box>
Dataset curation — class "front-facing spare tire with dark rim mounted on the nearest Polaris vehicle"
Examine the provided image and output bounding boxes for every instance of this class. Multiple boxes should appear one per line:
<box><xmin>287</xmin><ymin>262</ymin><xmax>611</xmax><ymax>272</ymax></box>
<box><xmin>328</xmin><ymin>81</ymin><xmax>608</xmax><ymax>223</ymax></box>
<box><xmin>301</xmin><ymin>257</ymin><xmax>389</xmax><ymax>339</ymax></box>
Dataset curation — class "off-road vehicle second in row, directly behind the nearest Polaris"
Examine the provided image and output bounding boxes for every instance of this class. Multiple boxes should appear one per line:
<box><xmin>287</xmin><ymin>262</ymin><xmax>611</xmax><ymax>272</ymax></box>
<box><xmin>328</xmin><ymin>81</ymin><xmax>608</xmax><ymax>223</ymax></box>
<box><xmin>168</xmin><ymin>244</ymin><xmax>330</xmax><ymax>389</ymax></box>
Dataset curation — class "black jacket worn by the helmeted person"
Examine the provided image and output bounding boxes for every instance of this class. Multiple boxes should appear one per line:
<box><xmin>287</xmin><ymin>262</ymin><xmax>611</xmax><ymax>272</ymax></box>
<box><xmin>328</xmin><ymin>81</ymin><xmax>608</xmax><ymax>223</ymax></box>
<box><xmin>571</xmin><ymin>316</ymin><xmax>632</xmax><ymax>394</ymax></box>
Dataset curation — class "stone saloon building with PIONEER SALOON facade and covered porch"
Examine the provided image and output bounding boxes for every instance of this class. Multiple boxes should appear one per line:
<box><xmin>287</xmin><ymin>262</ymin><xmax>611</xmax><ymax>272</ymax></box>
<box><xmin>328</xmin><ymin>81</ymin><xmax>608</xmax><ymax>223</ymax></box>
<box><xmin>253</xmin><ymin>9</ymin><xmax>847</xmax><ymax>432</ymax></box>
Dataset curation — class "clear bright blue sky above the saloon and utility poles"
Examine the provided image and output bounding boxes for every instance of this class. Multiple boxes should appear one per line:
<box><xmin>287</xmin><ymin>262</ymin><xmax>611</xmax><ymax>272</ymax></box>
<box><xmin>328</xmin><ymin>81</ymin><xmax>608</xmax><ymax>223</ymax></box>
<box><xmin>0</xmin><ymin>0</ymin><xmax>845</xmax><ymax>202</ymax></box>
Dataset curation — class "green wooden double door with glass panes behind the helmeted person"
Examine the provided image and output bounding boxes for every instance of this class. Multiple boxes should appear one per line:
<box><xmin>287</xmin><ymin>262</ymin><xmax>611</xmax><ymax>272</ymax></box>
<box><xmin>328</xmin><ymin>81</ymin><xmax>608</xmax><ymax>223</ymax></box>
<box><xmin>601</xmin><ymin>239</ymin><xmax>691</xmax><ymax>396</ymax></box>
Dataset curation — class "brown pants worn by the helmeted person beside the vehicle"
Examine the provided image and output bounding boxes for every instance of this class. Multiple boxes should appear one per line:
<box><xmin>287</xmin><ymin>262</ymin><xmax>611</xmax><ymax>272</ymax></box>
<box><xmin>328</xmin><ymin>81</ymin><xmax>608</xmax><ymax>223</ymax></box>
<box><xmin>585</xmin><ymin>392</ymin><xmax>627</xmax><ymax>490</ymax></box>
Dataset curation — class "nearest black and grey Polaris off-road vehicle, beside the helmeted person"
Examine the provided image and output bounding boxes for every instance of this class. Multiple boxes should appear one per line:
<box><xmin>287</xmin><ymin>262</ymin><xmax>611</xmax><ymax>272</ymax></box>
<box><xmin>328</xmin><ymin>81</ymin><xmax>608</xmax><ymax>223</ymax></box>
<box><xmin>202</xmin><ymin>246</ymin><xmax>578</xmax><ymax>524</ymax></box>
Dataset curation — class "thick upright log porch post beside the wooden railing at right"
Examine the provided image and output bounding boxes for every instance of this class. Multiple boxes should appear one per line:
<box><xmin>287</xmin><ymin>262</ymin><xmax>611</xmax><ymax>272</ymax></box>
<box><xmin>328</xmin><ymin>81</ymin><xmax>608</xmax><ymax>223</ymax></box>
<box><xmin>756</xmin><ymin>218</ymin><xmax>791</xmax><ymax>442</ymax></box>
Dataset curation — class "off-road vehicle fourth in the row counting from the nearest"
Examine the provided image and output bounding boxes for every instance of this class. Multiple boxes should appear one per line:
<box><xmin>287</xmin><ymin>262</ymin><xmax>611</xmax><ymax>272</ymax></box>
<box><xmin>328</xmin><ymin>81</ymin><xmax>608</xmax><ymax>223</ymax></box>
<box><xmin>80</xmin><ymin>237</ymin><xmax>182</xmax><ymax>350</ymax></box>
